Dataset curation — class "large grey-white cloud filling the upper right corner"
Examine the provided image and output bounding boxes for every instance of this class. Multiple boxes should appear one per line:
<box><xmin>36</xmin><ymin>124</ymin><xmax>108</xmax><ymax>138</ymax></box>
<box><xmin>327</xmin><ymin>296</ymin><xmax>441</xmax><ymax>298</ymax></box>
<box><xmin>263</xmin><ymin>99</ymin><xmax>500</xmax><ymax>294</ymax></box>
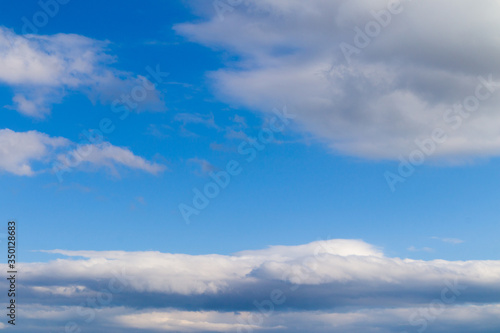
<box><xmin>175</xmin><ymin>0</ymin><xmax>500</xmax><ymax>159</ymax></box>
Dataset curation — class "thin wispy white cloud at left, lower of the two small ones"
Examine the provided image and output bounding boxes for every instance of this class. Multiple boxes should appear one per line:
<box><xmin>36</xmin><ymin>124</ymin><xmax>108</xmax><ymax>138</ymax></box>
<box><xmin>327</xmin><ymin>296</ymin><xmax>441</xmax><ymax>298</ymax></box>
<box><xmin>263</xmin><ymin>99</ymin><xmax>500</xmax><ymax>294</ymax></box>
<box><xmin>0</xmin><ymin>129</ymin><xmax>165</xmax><ymax>176</ymax></box>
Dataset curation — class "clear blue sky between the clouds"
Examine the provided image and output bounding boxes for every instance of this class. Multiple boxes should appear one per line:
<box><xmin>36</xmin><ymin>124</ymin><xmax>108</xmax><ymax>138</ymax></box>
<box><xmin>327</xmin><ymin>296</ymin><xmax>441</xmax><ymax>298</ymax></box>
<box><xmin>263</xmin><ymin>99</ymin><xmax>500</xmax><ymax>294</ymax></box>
<box><xmin>1</xmin><ymin>1</ymin><xmax>499</xmax><ymax>260</ymax></box>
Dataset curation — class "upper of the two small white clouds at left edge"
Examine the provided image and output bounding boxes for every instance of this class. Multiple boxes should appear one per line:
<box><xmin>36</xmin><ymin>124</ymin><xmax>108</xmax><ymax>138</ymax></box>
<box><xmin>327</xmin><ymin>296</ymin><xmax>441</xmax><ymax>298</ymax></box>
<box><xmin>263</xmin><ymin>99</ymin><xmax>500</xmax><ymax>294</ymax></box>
<box><xmin>0</xmin><ymin>27</ymin><xmax>164</xmax><ymax>118</ymax></box>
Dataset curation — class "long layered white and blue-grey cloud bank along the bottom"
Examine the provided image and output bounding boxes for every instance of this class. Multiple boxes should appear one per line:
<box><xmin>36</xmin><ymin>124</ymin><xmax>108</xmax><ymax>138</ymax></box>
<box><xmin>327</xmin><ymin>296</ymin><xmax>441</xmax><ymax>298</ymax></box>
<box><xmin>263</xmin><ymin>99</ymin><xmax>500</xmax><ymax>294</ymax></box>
<box><xmin>8</xmin><ymin>239</ymin><xmax>500</xmax><ymax>332</ymax></box>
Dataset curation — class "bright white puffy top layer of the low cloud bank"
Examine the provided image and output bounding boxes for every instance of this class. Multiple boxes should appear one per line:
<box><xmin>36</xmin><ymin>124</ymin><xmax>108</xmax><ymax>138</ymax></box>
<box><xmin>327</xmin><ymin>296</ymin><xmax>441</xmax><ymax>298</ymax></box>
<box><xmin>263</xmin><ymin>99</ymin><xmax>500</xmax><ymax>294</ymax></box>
<box><xmin>24</xmin><ymin>240</ymin><xmax>500</xmax><ymax>294</ymax></box>
